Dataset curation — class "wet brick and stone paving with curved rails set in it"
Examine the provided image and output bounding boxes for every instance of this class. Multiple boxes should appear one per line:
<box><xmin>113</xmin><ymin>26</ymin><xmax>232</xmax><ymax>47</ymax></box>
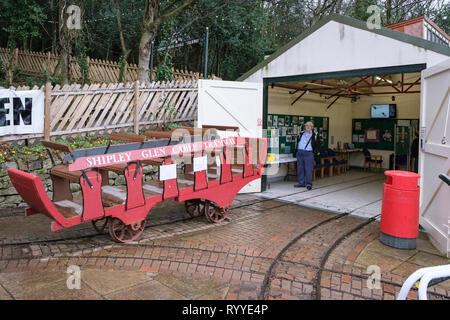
<box><xmin>0</xmin><ymin>195</ymin><xmax>450</xmax><ymax>300</ymax></box>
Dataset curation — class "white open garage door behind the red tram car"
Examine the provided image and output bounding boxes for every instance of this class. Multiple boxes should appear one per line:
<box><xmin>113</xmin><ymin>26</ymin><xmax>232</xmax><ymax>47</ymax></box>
<box><xmin>197</xmin><ymin>80</ymin><xmax>263</xmax><ymax>192</ymax></box>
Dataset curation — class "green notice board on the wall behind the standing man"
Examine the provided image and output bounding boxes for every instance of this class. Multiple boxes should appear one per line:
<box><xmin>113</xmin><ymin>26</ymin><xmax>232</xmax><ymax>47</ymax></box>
<box><xmin>267</xmin><ymin>114</ymin><xmax>330</xmax><ymax>154</ymax></box>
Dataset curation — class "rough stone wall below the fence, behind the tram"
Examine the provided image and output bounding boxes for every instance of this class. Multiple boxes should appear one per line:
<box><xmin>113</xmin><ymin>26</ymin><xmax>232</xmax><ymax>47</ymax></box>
<box><xmin>0</xmin><ymin>153</ymin><xmax>158</xmax><ymax>209</ymax></box>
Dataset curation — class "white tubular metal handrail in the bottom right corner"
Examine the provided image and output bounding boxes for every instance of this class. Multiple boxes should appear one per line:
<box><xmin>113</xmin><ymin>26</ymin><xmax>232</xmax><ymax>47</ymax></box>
<box><xmin>397</xmin><ymin>264</ymin><xmax>450</xmax><ymax>300</ymax></box>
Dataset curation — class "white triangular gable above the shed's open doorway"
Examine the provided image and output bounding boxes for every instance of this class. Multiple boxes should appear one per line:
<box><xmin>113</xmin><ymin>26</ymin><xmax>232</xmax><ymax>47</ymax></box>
<box><xmin>244</xmin><ymin>21</ymin><xmax>448</xmax><ymax>82</ymax></box>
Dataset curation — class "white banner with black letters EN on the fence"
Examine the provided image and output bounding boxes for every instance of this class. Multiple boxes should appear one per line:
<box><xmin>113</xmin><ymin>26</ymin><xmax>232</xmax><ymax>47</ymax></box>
<box><xmin>0</xmin><ymin>89</ymin><xmax>44</xmax><ymax>136</ymax></box>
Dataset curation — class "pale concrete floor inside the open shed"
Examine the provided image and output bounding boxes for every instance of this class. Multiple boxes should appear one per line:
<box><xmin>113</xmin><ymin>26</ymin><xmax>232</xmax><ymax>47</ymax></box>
<box><xmin>260</xmin><ymin>168</ymin><xmax>386</xmax><ymax>219</ymax></box>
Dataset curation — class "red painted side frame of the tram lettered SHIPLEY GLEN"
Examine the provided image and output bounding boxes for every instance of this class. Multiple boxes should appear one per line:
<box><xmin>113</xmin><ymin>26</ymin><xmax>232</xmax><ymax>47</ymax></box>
<box><xmin>8</xmin><ymin>137</ymin><xmax>267</xmax><ymax>242</ymax></box>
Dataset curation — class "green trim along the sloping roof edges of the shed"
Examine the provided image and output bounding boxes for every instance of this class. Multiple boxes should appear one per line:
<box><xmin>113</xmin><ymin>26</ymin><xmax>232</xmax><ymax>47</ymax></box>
<box><xmin>236</xmin><ymin>14</ymin><xmax>450</xmax><ymax>81</ymax></box>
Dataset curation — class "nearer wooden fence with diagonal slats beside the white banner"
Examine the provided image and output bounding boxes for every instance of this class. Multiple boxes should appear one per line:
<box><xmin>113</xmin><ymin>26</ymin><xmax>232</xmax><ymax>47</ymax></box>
<box><xmin>0</xmin><ymin>81</ymin><xmax>198</xmax><ymax>142</ymax></box>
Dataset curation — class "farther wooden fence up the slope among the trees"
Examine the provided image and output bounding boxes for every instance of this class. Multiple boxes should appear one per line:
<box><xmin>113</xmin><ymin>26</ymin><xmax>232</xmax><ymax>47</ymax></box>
<box><xmin>0</xmin><ymin>48</ymin><xmax>216</xmax><ymax>83</ymax></box>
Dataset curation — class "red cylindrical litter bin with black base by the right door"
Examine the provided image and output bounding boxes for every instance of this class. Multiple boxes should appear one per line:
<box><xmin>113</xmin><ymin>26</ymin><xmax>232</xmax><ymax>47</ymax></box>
<box><xmin>380</xmin><ymin>170</ymin><xmax>420</xmax><ymax>249</ymax></box>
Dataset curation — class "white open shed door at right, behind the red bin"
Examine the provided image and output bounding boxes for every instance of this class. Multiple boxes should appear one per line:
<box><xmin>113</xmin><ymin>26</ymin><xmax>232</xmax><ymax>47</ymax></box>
<box><xmin>419</xmin><ymin>59</ymin><xmax>450</xmax><ymax>256</ymax></box>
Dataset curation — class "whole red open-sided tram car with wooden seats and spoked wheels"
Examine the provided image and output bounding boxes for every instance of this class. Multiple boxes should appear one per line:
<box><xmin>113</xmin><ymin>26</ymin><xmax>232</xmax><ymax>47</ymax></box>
<box><xmin>8</xmin><ymin>130</ymin><xmax>267</xmax><ymax>243</ymax></box>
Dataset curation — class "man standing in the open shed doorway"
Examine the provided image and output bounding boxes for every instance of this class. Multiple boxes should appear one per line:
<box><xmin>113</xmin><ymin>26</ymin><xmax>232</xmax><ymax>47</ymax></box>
<box><xmin>294</xmin><ymin>121</ymin><xmax>320</xmax><ymax>190</ymax></box>
